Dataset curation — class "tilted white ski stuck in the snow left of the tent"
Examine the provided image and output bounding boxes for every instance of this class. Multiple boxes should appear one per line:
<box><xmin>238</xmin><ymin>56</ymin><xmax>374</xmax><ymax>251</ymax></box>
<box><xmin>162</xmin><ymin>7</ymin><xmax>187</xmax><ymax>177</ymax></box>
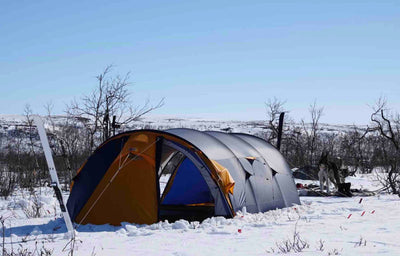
<box><xmin>33</xmin><ymin>115</ymin><xmax>74</xmax><ymax>238</ymax></box>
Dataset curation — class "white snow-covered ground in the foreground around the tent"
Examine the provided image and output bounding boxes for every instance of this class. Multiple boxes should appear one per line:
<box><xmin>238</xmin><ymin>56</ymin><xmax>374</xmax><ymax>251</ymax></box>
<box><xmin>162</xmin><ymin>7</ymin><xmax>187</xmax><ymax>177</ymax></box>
<box><xmin>0</xmin><ymin>175</ymin><xmax>400</xmax><ymax>256</ymax></box>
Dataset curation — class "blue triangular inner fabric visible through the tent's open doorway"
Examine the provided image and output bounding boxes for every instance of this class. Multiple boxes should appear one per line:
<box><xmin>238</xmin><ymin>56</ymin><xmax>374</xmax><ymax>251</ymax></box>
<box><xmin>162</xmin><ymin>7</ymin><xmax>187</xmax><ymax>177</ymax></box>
<box><xmin>162</xmin><ymin>158</ymin><xmax>213</xmax><ymax>205</ymax></box>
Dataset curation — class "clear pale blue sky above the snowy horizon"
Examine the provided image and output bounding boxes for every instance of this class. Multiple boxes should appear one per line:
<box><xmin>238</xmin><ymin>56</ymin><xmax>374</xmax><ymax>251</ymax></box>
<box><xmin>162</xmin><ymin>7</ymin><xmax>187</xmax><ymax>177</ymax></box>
<box><xmin>0</xmin><ymin>0</ymin><xmax>400</xmax><ymax>124</ymax></box>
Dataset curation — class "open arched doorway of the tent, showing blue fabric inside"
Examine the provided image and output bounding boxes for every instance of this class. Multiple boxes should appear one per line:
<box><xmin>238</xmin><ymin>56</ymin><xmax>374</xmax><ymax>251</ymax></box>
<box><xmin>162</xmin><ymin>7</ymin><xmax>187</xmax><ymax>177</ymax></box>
<box><xmin>159</xmin><ymin>145</ymin><xmax>215</xmax><ymax>221</ymax></box>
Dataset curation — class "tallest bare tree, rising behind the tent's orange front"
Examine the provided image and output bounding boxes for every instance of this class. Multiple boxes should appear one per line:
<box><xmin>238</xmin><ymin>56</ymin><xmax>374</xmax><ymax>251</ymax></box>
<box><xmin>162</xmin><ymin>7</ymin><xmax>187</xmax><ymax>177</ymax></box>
<box><xmin>67</xmin><ymin>65</ymin><xmax>164</xmax><ymax>151</ymax></box>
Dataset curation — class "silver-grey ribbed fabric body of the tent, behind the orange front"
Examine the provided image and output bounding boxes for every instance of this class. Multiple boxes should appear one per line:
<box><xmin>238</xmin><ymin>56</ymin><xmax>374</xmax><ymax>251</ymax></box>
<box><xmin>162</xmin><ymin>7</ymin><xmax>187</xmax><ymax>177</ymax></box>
<box><xmin>166</xmin><ymin>128</ymin><xmax>300</xmax><ymax>213</ymax></box>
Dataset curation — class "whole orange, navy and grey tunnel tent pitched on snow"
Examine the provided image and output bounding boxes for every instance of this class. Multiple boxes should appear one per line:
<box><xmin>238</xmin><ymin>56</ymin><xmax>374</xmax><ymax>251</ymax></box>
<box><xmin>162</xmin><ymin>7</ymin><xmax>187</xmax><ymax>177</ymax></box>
<box><xmin>67</xmin><ymin>129</ymin><xmax>300</xmax><ymax>225</ymax></box>
